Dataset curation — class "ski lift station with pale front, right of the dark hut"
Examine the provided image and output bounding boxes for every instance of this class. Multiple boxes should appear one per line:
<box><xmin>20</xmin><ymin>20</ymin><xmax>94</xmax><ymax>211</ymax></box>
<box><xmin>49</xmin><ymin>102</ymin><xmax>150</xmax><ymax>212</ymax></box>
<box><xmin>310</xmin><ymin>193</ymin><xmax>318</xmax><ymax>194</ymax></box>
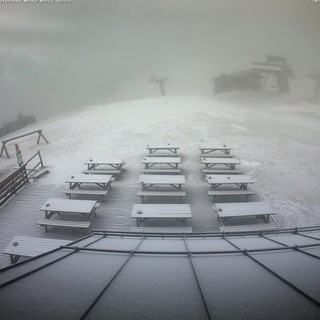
<box><xmin>251</xmin><ymin>54</ymin><xmax>291</xmax><ymax>92</ymax></box>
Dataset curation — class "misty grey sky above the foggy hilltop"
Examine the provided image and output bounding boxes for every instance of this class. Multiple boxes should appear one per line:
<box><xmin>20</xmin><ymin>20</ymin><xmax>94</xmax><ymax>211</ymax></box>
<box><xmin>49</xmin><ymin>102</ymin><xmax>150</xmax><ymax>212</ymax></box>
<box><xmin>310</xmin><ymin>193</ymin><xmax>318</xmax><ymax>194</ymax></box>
<box><xmin>0</xmin><ymin>0</ymin><xmax>320</xmax><ymax>125</ymax></box>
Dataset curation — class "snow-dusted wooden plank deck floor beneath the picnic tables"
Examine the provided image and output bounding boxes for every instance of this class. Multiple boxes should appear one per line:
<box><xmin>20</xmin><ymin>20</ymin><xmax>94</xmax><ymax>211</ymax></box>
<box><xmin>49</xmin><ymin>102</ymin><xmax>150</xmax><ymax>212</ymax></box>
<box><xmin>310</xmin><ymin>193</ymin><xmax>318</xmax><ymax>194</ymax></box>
<box><xmin>0</xmin><ymin>176</ymin><xmax>260</xmax><ymax>268</ymax></box>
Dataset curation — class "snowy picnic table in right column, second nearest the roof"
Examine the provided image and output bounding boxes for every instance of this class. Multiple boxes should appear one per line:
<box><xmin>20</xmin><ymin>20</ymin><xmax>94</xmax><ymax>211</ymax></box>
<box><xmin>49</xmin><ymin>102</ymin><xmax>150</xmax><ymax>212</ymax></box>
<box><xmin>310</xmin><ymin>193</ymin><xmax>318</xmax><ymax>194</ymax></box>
<box><xmin>207</xmin><ymin>174</ymin><xmax>255</xmax><ymax>190</ymax></box>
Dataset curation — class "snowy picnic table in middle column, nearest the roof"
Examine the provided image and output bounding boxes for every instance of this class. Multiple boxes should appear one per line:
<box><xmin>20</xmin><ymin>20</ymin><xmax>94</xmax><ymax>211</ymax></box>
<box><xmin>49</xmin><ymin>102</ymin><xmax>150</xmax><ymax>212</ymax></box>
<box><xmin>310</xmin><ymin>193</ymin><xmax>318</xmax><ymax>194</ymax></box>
<box><xmin>131</xmin><ymin>204</ymin><xmax>192</xmax><ymax>227</ymax></box>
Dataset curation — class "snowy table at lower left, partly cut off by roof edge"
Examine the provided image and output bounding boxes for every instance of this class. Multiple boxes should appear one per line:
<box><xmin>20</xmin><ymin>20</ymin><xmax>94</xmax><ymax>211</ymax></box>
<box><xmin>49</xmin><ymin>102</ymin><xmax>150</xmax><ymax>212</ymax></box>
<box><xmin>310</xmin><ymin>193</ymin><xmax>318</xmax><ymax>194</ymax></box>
<box><xmin>3</xmin><ymin>236</ymin><xmax>71</xmax><ymax>264</ymax></box>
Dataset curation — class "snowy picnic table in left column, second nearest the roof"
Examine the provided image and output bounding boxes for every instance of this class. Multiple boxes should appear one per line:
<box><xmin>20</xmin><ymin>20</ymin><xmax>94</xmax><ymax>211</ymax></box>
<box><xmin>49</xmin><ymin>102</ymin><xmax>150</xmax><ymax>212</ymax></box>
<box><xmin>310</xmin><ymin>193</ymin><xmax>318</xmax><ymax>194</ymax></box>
<box><xmin>40</xmin><ymin>198</ymin><xmax>97</xmax><ymax>220</ymax></box>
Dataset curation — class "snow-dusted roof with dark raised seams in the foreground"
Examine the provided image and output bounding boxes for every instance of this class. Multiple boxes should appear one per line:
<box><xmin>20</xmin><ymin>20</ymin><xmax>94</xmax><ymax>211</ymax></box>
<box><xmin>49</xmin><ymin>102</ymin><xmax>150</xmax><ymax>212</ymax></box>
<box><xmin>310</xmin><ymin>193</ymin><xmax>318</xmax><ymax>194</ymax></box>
<box><xmin>0</xmin><ymin>227</ymin><xmax>320</xmax><ymax>320</ymax></box>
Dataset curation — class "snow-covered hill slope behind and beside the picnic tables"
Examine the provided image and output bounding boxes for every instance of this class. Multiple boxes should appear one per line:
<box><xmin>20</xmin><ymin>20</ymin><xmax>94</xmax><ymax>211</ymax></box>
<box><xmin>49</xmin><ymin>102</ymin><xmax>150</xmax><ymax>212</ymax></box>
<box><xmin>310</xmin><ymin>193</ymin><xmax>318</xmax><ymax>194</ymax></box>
<box><xmin>0</xmin><ymin>91</ymin><xmax>320</xmax><ymax>227</ymax></box>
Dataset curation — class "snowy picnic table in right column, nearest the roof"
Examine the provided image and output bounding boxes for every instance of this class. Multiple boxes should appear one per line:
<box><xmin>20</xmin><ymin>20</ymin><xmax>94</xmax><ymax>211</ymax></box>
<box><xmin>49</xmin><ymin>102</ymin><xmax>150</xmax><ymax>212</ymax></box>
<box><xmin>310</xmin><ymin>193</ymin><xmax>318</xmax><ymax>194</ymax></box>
<box><xmin>213</xmin><ymin>202</ymin><xmax>275</xmax><ymax>223</ymax></box>
